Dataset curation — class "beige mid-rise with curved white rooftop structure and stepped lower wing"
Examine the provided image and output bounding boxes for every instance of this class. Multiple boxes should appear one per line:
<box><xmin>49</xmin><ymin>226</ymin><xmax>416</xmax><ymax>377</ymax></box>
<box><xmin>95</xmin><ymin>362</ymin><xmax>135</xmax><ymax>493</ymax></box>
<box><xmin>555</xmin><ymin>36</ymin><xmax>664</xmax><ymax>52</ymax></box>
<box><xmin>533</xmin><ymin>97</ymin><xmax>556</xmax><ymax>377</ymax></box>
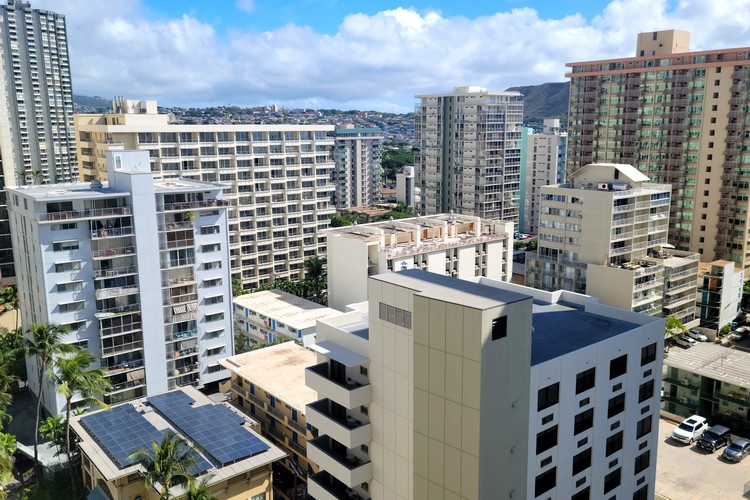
<box><xmin>526</xmin><ymin>163</ymin><xmax>700</xmax><ymax>326</ymax></box>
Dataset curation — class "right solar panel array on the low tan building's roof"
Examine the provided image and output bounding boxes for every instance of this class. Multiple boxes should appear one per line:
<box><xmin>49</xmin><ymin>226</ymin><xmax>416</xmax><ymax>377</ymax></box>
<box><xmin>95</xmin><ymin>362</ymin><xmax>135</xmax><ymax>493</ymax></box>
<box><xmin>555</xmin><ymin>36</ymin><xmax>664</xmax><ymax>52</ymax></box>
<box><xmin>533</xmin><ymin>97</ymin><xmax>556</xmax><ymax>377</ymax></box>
<box><xmin>148</xmin><ymin>391</ymin><xmax>269</xmax><ymax>465</ymax></box>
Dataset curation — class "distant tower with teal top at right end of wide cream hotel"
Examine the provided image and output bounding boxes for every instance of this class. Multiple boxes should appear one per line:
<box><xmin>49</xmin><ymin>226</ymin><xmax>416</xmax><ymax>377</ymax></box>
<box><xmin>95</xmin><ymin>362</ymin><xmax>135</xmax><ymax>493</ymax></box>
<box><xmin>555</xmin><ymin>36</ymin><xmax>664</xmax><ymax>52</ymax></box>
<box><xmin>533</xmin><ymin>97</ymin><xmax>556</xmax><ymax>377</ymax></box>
<box><xmin>333</xmin><ymin>125</ymin><xmax>383</xmax><ymax>208</ymax></box>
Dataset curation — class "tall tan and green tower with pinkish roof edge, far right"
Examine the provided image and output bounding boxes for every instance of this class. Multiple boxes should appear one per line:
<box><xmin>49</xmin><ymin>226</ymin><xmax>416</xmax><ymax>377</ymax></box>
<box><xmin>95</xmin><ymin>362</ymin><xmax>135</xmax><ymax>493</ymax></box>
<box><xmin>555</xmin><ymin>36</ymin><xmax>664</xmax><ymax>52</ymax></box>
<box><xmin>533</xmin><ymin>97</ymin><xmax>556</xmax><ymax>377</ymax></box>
<box><xmin>566</xmin><ymin>30</ymin><xmax>750</xmax><ymax>268</ymax></box>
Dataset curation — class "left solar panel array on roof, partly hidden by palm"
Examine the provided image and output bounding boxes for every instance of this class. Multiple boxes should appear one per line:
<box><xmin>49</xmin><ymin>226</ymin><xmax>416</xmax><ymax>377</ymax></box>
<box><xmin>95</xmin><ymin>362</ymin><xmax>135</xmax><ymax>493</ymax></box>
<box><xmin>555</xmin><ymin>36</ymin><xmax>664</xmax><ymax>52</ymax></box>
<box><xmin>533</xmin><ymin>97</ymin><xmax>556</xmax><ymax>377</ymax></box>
<box><xmin>81</xmin><ymin>404</ymin><xmax>211</xmax><ymax>476</ymax></box>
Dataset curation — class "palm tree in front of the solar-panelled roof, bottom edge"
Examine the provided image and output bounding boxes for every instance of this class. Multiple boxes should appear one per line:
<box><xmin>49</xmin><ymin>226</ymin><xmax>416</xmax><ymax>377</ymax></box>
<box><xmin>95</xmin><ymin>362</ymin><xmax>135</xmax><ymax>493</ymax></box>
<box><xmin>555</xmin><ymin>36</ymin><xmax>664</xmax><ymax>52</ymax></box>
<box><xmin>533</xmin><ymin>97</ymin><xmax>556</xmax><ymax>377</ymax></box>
<box><xmin>128</xmin><ymin>432</ymin><xmax>195</xmax><ymax>500</ymax></box>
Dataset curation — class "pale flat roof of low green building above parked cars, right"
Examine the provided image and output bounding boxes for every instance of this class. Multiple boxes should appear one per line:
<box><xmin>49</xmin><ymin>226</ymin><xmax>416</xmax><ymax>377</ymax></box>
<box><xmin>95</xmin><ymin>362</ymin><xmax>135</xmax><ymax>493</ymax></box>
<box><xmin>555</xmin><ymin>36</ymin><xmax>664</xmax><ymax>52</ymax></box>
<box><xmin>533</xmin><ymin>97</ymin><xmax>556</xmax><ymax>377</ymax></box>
<box><xmin>664</xmin><ymin>342</ymin><xmax>750</xmax><ymax>389</ymax></box>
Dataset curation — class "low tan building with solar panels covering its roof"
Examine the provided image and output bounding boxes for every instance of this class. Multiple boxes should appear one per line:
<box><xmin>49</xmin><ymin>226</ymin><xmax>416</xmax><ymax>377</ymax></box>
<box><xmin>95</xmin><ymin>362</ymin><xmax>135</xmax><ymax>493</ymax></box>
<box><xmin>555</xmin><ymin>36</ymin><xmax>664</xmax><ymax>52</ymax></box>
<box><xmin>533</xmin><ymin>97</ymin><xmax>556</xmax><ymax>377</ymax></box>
<box><xmin>71</xmin><ymin>387</ymin><xmax>286</xmax><ymax>500</ymax></box>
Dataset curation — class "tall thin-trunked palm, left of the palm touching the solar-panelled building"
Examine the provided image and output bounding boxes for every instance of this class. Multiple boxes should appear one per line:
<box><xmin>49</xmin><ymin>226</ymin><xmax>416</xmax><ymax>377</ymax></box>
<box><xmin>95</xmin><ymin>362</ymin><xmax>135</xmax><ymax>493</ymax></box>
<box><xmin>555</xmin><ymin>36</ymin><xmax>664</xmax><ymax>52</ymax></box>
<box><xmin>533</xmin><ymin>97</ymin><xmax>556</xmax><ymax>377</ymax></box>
<box><xmin>24</xmin><ymin>324</ymin><xmax>77</xmax><ymax>485</ymax></box>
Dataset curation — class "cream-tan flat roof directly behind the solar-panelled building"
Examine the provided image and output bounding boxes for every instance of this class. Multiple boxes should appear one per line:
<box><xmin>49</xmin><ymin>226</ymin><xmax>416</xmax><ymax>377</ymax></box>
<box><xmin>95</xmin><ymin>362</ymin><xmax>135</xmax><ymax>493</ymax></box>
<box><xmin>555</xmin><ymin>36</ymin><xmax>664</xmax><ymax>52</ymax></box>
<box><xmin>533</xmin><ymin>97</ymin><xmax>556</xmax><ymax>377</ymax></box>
<box><xmin>219</xmin><ymin>341</ymin><xmax>318</xmax><ymax>415</ymax></box>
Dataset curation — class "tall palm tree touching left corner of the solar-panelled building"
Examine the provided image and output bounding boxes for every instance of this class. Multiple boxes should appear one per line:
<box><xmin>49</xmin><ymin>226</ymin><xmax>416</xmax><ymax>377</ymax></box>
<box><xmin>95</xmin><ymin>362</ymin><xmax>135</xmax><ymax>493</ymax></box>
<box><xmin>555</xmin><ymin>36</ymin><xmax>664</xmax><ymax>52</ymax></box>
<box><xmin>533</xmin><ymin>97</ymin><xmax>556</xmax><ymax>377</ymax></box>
<box><xmin>53</xmin><ymin>349</ymin><xmax>109</xmax><ymax>495</ymax></box>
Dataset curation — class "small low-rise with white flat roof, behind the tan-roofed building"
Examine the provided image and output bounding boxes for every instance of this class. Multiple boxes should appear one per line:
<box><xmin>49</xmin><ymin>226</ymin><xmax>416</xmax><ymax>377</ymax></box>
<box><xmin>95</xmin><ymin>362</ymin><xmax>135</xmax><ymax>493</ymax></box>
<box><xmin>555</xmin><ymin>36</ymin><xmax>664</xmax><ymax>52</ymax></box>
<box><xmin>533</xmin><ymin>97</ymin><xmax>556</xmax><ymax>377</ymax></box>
<box><xmin>232</xmin><ymin>290</ymin><xmax>341</xmax><ymax>345</ymax></box>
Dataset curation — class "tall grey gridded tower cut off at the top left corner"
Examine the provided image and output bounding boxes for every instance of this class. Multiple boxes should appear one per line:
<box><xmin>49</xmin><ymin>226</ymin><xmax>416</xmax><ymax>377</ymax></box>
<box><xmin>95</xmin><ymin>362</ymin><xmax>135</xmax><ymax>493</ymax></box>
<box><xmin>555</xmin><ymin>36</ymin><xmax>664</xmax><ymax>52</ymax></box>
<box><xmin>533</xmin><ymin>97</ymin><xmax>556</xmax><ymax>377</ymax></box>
<box><xmin>0</xmin><ymin>0</ymin><xmax>78</xmax><ymax>282</ymax></box>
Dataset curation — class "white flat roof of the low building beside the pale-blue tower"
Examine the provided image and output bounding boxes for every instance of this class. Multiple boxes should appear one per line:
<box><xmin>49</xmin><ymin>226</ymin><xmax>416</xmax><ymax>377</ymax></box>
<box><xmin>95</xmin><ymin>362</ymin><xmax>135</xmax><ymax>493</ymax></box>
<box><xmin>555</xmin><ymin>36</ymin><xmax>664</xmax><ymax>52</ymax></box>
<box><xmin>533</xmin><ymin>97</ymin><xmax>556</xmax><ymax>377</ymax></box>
<box><xmin>232</xmin><ymin>290</ymin><xmax>343</xmax><ymax>330</ymax></box>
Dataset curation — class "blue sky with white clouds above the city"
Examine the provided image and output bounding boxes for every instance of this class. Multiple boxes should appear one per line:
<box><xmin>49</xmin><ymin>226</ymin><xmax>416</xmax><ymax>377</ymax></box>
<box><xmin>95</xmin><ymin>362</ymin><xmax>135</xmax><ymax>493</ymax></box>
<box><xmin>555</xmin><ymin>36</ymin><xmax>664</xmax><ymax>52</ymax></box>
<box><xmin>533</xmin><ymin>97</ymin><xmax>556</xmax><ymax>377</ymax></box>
<box><xmin>31</xmin><ymin>0</ymin><xmax>750</xmax><ymax>112</ymax></box>
